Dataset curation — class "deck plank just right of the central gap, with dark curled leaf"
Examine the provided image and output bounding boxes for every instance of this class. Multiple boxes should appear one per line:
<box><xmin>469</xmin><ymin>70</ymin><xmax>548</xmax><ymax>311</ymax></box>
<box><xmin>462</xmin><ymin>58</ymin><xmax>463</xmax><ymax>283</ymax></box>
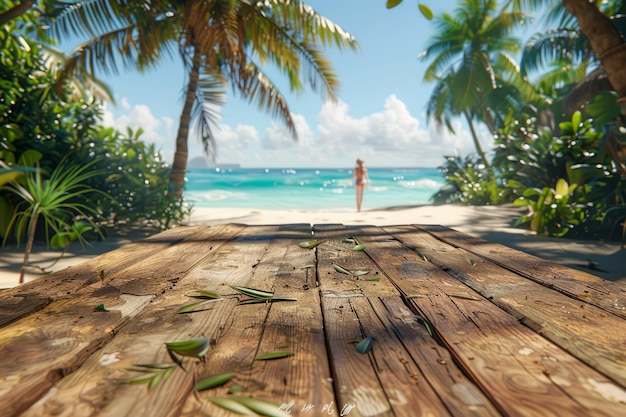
<box><xmin>316</xmin><ymin>226</ymin><xmax>456</xmax><ymax>416</ymax></box>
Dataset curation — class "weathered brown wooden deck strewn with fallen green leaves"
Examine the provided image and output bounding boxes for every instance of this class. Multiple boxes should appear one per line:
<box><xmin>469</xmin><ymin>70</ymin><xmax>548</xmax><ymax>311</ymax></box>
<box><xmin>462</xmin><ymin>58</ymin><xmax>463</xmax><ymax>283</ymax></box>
<box><xmin>0</xmin><ymin>224</ymin><xmax>626</xmax><ymax>417</ymax></box>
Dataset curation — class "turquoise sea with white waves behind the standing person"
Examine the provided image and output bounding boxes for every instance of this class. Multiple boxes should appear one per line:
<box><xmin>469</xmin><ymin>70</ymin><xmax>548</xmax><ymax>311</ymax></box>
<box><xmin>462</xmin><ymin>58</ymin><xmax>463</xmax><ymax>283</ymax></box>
<box><xmin>185</xmin><ymin>168</ymin><xmax>444</xmax><ymax>211</ymax></box>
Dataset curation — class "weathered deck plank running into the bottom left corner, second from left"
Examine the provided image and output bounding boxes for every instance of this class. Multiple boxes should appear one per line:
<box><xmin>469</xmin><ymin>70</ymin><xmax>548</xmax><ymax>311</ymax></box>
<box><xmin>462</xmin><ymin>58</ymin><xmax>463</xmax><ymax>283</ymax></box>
<box><xmin>0</xmin><ymin>223</ymin><xmax>241</xmax><ymax>414</ymax></box>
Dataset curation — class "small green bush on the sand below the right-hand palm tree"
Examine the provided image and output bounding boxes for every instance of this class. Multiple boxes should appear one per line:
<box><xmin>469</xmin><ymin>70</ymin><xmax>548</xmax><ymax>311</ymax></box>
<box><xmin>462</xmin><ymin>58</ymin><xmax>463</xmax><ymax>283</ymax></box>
<box><xmin>430</xmin><ymin>156</ymin><xmax>511</xmax><ymax>205</ymax></box>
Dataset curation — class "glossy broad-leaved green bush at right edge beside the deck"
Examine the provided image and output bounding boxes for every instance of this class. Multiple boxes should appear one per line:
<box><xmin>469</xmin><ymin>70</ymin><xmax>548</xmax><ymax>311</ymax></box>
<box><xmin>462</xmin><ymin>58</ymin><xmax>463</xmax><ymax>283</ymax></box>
<box><xmin>494</xmin><ymin>112</ymin><xmax>624</xmax><ymax>237</ymax></box>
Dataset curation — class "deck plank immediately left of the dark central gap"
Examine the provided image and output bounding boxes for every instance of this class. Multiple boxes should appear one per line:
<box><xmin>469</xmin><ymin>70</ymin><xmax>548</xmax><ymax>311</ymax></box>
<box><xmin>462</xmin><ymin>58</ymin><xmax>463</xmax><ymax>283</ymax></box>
<box><xmin>205</xmin><ymin>225</ymin><xmax>335</xmax><ymax>415</ymax></box>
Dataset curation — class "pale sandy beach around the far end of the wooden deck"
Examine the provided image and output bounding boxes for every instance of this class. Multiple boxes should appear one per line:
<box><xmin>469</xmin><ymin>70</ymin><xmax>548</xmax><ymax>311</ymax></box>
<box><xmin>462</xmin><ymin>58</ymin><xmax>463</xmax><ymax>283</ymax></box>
<box><xmin>0</xmin><ymin>205</ymin><xmax>626</xmax><ymax>289</ymax></box>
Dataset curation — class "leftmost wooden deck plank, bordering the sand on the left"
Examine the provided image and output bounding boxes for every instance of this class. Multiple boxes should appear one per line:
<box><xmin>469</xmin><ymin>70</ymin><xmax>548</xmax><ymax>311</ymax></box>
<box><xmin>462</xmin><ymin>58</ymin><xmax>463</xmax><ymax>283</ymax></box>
<box><xmin>0</xmin><ymin>228</ymin><xmax>210</xmax><ymax>326</ymax></box>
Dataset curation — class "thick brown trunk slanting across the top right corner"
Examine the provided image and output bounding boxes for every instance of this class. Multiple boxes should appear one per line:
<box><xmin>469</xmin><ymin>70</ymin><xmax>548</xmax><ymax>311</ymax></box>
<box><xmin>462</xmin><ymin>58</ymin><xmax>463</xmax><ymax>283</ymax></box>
<box><xmin>562</xmin><ymin>0</ymin><xmax>626</xmax><ymax>97</ymax></box>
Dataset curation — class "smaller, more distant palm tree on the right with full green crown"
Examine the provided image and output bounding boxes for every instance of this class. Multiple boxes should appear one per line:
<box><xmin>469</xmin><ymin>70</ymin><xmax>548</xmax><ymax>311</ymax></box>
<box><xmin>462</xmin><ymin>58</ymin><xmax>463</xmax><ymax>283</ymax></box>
<box><xmin>422</xmin><ymin>0</ymin><xmax>527</xmax><ymax>166</ymax></box>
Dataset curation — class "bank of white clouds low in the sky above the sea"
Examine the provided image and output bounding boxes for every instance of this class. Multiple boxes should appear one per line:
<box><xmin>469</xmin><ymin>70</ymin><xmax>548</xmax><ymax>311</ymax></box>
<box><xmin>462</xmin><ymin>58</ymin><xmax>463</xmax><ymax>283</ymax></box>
<box><xmin>104</xmin><ymin>95</ymin><xmax>482</xmax><ymax>168</ymax></box>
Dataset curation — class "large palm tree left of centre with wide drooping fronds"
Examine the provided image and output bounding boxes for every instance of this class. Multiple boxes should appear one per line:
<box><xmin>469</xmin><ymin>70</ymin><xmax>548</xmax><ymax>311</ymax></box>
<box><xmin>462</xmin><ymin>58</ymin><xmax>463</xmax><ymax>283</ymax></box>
<box><xmin>53</xmin><ymin>0</ymin><xmax>358</xmax><ymax>198</ymax></box>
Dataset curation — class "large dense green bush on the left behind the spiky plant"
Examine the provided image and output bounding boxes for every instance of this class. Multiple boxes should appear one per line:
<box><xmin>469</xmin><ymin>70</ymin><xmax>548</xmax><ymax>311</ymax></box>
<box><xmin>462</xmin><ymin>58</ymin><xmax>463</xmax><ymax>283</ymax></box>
<box><xmin>0</xmin><ymin>6</ymin><xmax>189</xmax><ymax>247</ymax></box>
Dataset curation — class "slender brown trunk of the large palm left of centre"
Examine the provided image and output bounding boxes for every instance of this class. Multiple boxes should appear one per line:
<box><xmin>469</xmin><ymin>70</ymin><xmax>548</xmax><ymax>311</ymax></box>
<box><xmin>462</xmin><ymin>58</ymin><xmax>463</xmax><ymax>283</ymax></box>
<box><xmin>169</xmin><ymin>48</ymin><xmax>202</xmax><ymax>199</ymax></box>
